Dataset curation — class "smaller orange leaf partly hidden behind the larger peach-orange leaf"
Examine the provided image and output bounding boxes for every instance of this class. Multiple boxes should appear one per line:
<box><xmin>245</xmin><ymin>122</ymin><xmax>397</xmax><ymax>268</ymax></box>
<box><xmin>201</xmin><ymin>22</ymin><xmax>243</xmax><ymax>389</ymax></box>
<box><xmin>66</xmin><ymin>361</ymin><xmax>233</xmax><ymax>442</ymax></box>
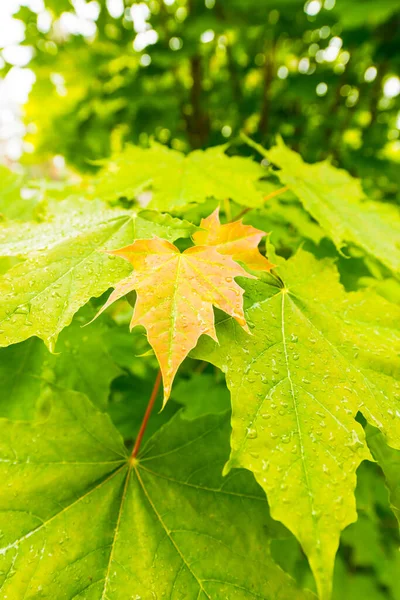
<box><xmin>193</xmin><ymin>208</ymin><xmax>274</xmax><ymax>271</ymax></box>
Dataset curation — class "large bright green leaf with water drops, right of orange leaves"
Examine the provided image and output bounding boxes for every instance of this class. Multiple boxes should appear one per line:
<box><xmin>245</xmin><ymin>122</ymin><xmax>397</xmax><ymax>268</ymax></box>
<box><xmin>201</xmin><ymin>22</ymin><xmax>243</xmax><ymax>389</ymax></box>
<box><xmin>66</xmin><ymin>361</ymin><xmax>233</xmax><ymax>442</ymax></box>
<box><xmin>195</xmin><ymin>252</ymin><xmax>400</xmax><ymax>599</ymax></box>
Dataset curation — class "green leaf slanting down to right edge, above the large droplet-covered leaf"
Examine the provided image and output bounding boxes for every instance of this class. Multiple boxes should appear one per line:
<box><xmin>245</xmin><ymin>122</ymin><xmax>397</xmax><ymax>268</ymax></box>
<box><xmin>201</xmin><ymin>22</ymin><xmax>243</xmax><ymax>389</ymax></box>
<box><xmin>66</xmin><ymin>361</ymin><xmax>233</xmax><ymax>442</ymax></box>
<box><xmin>261</xmin><ymin>139</ymin><xmax>400</xmax><ymax>273</ymax></box>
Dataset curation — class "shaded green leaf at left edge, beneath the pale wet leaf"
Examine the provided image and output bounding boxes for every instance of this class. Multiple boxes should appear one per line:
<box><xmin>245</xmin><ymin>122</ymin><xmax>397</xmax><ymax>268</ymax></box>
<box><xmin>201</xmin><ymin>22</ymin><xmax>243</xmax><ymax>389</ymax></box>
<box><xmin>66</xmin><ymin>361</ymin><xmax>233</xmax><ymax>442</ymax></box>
<box><xmin>0</xmin><ymin>307</ymin><xmax>122</xmax><ymax>419</ymax></box>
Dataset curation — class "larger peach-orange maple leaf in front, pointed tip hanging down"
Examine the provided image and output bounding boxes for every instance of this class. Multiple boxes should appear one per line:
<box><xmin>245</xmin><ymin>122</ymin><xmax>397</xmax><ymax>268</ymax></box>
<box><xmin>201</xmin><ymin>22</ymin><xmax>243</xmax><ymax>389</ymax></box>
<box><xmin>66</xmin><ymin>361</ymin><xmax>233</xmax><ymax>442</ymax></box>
<box><xmin>98</xmin><ymin>237</ymin><xmax>254</xmax><ymax>405</ymax></box>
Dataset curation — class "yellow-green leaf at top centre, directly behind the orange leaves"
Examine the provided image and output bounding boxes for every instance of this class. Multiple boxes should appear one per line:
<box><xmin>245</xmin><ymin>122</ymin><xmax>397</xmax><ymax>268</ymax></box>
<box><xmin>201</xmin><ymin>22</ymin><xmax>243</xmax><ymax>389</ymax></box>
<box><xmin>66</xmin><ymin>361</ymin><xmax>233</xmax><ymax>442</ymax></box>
<box><xmin>96</xmin><ymin>143</ymin><xmax>265</xmax><ymax>211</ymax></box>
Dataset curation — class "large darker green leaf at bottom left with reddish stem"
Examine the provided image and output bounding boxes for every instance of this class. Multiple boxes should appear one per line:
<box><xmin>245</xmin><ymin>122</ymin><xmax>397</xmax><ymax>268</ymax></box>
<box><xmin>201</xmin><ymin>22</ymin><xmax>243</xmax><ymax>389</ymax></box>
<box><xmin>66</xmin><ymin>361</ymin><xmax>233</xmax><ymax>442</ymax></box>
<box><xmin>0</xmin><ymin>392</ymin><xmax>313</xmax><ymax>600</ymax></box>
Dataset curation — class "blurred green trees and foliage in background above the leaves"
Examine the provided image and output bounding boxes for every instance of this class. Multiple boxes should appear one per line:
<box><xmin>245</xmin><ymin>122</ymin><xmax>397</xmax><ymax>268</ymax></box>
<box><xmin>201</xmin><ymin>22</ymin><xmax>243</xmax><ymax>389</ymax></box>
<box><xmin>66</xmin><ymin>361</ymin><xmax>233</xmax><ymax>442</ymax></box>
<box><xmin>5</xmin><ymin>0</ymin><xmax>400</xmax><ymax>199</ymax></box>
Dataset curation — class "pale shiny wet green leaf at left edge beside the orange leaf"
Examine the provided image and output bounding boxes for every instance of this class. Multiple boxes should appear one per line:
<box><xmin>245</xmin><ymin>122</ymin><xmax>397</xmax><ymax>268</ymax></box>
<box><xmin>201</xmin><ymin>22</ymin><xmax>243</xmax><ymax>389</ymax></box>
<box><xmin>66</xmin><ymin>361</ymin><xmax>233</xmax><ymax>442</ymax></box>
<box><xmin>0</xmin><ymin>202</ymin><xmax>196</xmax><ymax>347</ymax></box>
